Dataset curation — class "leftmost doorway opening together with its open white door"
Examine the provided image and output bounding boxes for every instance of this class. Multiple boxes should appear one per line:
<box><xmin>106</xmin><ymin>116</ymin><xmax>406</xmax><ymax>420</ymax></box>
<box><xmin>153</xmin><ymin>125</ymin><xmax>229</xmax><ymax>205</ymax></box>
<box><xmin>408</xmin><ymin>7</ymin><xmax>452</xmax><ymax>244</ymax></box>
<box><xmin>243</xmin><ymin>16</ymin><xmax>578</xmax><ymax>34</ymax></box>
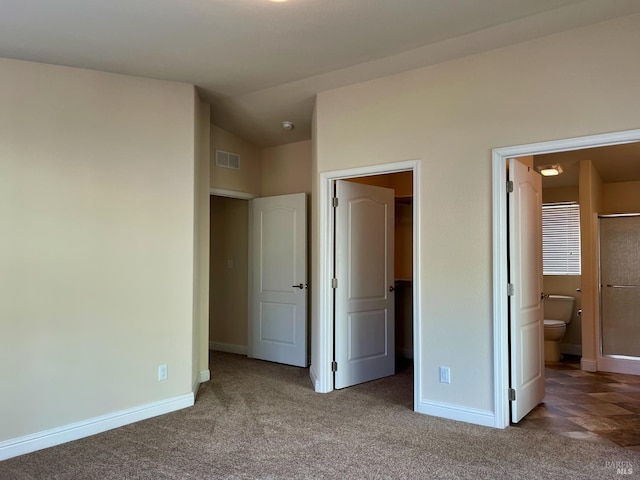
<box><xmin>209</xmin><ymin>189</ymin><xmax>308</xmax><ymax>367</ymax></box>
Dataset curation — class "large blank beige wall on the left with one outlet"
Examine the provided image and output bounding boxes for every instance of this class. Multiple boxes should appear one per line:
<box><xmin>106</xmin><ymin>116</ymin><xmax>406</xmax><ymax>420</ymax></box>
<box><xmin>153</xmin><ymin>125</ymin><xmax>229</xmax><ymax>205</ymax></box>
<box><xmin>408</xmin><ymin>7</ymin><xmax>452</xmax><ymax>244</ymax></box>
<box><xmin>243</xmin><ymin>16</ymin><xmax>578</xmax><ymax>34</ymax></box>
<box><xmin>0</xmin><ymin>59</ymin><xmax>196</xmax><ymax>441</ymax></box>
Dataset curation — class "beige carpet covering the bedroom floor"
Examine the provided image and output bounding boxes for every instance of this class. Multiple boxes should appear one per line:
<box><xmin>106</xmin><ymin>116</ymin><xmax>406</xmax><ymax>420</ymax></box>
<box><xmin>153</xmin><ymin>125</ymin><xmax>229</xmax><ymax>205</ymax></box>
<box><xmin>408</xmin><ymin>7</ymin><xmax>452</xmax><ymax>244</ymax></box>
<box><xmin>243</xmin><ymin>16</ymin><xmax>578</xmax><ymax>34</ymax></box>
<box><xmin>0</xmin><ymin>353</ymin><xmax>640</xmax><ymax>480</ymax></box>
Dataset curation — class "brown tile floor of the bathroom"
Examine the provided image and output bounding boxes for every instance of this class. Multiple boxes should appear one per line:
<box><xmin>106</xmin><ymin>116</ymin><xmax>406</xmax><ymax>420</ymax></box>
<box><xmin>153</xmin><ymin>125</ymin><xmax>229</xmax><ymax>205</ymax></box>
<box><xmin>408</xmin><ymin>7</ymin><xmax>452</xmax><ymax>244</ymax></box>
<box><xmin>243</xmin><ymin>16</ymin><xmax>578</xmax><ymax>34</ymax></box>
<box><xmin>515</xmin><ymin>356</ymin><xmax>640</xmax><ymax>451</ymax></box>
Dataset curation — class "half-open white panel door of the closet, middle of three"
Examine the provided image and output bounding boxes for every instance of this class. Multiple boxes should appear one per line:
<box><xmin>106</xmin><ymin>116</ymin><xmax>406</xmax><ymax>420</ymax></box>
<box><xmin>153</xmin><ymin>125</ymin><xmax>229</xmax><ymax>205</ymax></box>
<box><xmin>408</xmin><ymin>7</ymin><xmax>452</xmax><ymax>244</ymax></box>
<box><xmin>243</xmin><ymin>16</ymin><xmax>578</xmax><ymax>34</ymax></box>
<box><xmin>334</xmin><ymin>180</ymin><xmax>395</xmax><ymax>388</ymax></box>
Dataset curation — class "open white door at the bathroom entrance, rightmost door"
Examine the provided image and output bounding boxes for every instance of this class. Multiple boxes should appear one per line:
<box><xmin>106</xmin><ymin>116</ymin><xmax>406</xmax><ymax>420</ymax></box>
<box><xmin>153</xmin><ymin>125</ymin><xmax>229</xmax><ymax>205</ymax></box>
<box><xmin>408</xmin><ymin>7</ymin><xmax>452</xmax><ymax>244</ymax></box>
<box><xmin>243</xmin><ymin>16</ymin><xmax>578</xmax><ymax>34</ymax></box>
<box><xmin>509</xmin><ymin>158</ymin><xmax>544</xmax><ymax>423</ymax></box>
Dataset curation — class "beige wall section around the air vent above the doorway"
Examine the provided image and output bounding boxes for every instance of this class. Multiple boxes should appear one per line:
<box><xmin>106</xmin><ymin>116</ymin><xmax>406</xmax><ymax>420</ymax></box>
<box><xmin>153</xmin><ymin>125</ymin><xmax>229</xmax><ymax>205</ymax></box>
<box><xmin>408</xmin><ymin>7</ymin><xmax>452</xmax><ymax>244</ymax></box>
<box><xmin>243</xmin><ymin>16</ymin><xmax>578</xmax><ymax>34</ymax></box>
<box><xmin>210</xmin><ymin>125</ymin><xmax>261</xmax><ymax>196</ymax></box>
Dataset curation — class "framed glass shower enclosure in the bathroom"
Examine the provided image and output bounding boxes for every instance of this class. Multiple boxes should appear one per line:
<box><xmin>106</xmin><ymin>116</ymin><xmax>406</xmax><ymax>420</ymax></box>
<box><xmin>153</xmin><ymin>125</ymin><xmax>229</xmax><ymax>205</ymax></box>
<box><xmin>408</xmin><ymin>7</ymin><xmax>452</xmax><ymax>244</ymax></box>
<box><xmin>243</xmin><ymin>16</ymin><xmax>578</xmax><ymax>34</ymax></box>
<box><xmin>599</xmin><ymin>214</ymin><xmax>640</xmax><ymax>364</ymax></box>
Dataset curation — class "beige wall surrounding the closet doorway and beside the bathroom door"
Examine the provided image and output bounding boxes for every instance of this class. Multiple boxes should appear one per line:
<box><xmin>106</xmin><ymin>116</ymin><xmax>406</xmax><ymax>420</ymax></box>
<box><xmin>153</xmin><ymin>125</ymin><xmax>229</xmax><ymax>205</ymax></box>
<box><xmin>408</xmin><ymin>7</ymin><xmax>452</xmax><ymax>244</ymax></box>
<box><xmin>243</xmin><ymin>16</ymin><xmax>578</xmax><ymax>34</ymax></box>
<box><xmin>312</xmin><ymin>15</ymin><xmax>640</xmax><ymax>415</ymax></box>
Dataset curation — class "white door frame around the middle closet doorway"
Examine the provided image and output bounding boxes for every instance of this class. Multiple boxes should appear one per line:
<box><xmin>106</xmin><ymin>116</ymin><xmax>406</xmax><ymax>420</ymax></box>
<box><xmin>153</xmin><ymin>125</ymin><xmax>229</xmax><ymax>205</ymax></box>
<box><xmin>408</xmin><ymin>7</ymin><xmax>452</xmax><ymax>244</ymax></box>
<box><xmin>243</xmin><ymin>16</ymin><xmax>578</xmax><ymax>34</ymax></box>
<box><xmin>311</xmin><ymin>160</ymin><xmax>422</xmax><ymax>409</ymax></box>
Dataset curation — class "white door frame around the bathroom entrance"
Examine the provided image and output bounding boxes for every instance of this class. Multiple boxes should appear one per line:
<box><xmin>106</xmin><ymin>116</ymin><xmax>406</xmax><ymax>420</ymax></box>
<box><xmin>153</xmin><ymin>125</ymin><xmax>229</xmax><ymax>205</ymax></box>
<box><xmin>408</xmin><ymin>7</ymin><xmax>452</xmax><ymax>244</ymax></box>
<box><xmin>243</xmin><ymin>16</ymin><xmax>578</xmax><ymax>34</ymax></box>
<box><xmin>493</xmin><ymin>130</ymin><xmax>640</xmax><ymax>428</ymax></box>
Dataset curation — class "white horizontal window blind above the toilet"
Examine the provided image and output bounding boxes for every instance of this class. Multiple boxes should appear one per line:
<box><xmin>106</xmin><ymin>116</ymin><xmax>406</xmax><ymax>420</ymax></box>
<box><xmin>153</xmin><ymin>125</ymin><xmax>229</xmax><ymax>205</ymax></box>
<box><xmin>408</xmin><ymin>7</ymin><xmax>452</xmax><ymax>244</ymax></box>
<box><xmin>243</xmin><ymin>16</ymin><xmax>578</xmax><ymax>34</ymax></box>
<box><xmin>542</xmin><ymin>203</ymin><xmax>580</xmax><ymax>275</ymax></box>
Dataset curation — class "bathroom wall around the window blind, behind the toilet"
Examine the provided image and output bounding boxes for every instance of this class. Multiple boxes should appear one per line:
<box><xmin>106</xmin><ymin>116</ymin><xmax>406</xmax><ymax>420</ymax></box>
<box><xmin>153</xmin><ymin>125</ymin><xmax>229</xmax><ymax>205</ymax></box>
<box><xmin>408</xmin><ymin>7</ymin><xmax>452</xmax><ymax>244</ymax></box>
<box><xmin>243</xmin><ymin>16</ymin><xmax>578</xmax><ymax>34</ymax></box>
<box><xmin>542</xmin><ymin>186</ymin><xmax>582</xmax><ymax>355</ymax></box>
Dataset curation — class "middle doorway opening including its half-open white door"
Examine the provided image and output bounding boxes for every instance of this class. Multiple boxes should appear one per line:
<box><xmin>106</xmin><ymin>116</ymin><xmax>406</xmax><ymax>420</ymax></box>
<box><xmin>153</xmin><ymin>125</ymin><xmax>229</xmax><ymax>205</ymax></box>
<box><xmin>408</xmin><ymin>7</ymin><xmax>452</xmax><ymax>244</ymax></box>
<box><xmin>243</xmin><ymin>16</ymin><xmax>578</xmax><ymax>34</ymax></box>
<box><xmin>334</xmin><ymin>172</ymin><xmax>413</xmax><ymax>389</ymax></box>
